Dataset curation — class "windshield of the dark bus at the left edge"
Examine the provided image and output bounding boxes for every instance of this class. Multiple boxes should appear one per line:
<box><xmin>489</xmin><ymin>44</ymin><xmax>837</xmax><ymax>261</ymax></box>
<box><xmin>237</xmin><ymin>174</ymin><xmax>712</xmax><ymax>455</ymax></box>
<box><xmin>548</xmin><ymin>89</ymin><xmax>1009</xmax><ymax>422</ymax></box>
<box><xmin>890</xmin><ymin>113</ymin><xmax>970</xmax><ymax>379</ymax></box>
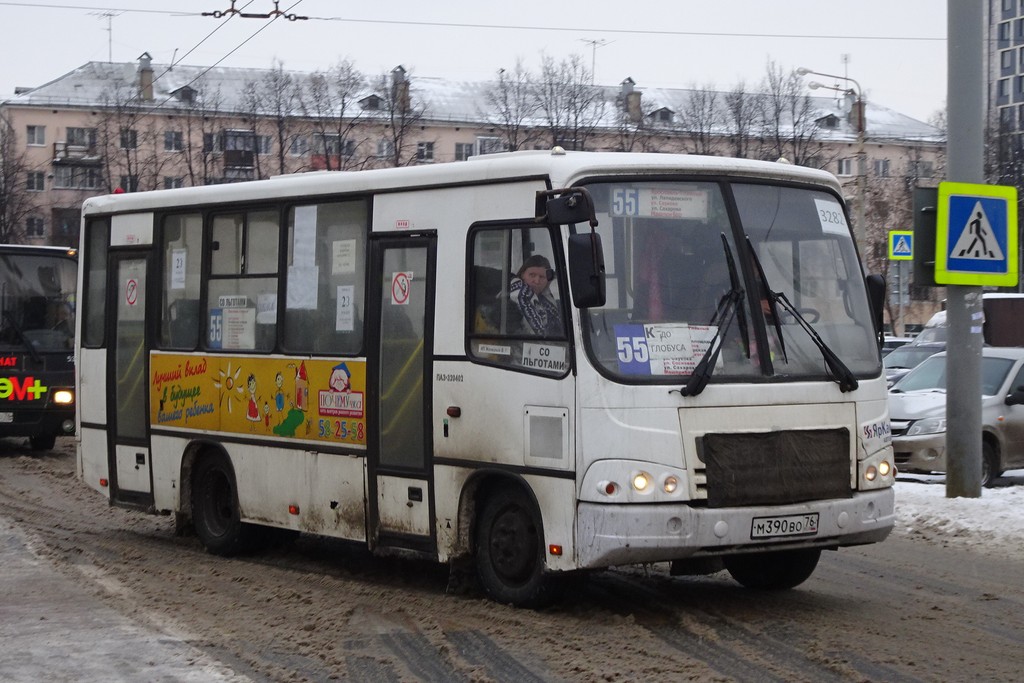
<box><xmin>0</xmin><ymin>253</ymin><xmax>77</xmax><ymax>352</ymax></box>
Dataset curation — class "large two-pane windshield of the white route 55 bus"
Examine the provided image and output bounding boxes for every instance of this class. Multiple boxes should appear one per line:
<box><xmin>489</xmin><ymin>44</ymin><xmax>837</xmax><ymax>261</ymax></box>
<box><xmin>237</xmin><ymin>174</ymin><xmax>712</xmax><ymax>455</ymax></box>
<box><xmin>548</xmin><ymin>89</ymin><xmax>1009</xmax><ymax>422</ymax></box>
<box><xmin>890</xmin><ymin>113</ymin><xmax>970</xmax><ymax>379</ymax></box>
<box><xmin>584</xmin><ymin>181</ymin><xmax>881</xmax><ymax>383</ymax></box>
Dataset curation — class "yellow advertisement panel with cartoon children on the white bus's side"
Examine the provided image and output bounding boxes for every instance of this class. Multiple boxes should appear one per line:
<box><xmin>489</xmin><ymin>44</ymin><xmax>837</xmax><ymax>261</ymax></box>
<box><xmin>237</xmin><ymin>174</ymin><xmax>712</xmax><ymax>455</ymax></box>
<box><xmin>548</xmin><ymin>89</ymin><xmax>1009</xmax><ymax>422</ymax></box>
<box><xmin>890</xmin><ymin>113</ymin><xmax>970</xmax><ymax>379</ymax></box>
<box><xmin>150</xmin><ymin>353</ymin><xmax>367</xmax><ymax>445</ymax></box>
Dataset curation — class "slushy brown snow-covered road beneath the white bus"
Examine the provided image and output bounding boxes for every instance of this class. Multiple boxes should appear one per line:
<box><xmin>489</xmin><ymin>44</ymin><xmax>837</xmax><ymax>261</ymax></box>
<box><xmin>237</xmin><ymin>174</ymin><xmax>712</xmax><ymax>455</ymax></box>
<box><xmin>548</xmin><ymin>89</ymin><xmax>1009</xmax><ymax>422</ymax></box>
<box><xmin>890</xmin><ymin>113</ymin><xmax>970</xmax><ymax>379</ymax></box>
<box><xmin>0</xmin><ymin>441</ymin><xmax>1024</xmax><ymax>683</ymax></box>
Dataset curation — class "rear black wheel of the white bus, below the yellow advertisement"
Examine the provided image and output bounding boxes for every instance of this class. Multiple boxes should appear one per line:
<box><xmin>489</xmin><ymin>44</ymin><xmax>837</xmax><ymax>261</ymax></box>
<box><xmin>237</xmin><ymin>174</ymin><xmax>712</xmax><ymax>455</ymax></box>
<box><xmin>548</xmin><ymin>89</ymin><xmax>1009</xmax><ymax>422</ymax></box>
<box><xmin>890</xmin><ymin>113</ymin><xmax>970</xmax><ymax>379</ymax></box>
<box><xmin>191</xmin><ymin>453</ymin><xmax>256</xmax><ymax>557</ymax></box>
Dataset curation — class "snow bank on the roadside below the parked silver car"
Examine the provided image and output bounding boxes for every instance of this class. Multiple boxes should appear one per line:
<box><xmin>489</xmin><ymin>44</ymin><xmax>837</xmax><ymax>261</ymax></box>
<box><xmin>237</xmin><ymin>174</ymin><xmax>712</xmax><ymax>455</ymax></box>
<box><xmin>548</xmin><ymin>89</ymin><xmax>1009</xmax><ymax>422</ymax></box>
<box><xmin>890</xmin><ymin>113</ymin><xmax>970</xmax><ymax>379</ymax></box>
<box><xmin>894</xmin><ymin>470</ymin><xmax>1024</xmax><ymax>558</ymax></box>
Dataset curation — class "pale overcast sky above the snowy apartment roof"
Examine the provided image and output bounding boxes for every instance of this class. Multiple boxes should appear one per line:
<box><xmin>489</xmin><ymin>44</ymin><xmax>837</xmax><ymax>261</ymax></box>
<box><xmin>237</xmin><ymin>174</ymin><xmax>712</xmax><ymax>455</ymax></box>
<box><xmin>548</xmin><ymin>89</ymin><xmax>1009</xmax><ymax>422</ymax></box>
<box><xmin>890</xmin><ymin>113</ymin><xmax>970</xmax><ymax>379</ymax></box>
<box><xmin>0</xmin><ymin>0</ymin><xmax>946</xmax><ymax>121</ymax></box>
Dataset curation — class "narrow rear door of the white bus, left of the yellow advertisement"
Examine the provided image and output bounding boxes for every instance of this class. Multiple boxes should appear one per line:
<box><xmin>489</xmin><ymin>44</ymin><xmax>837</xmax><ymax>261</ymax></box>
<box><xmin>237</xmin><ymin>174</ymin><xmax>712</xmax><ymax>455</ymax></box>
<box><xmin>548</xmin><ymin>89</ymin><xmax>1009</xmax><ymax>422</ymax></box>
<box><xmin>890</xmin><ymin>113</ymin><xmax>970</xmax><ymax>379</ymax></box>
<box><xmin>106</xmin><ymin>253</ymin><xmax>153</xmax><ymax>507</ymax></box>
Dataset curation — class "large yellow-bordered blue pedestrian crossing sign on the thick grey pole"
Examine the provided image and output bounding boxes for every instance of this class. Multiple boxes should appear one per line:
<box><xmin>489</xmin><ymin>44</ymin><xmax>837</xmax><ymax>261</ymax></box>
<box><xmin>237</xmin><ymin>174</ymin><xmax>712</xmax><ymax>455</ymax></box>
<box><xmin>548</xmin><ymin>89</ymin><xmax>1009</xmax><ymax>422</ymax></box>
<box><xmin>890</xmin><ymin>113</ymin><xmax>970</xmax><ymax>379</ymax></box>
<box><xmin>935</xmin><ymin>182</ymin><xmax>1018</xmax><ymax>287</ymax></box>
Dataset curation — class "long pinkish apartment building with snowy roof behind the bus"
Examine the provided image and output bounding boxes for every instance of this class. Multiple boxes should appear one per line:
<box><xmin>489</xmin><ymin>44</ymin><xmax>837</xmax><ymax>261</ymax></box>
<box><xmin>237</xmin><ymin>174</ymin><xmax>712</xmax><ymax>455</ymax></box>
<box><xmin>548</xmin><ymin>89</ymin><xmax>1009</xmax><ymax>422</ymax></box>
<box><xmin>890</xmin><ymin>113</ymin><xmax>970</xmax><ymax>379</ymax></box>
<box><xmin>0</xmin><ymin>54</ymin><xmax>945</xmax><ymax>327</ymax></box>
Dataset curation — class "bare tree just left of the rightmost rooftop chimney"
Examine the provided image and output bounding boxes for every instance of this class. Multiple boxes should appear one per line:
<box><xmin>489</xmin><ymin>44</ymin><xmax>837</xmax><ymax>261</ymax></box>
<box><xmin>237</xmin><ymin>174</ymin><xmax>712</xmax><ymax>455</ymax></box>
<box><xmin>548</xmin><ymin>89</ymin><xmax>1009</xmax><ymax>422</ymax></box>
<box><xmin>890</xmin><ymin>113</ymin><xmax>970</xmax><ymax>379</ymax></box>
<box><xmin>534</xmin><ymin>54</ymin><xmax>605</xmax><ymax>150</ymax></box>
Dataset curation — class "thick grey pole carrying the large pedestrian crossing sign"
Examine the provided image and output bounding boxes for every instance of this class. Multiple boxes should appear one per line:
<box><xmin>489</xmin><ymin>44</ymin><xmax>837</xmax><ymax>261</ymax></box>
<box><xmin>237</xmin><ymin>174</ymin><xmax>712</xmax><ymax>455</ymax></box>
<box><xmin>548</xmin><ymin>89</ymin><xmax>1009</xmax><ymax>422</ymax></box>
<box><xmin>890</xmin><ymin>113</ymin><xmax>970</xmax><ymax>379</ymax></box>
<box><xmin>946</xmin><ymin>0</ymin><xmax>985</xmax><ymax>498</ymax></box>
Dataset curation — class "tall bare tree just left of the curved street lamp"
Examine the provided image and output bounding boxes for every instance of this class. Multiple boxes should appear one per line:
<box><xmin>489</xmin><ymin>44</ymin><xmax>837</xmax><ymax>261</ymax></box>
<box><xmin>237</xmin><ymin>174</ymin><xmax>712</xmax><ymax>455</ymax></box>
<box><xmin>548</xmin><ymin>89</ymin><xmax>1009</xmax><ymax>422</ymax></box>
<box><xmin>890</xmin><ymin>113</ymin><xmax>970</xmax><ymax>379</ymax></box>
<box><xmin>760</xmin><ymin>60</ymin><xmax>818</xmax><ymax>166</ymax></box>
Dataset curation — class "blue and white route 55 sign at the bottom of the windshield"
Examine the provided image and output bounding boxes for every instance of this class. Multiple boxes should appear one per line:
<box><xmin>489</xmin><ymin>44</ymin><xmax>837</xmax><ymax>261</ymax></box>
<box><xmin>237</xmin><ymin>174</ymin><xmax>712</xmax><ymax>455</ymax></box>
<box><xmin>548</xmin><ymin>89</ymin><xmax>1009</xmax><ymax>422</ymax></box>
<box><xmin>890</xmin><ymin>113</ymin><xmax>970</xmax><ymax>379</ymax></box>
<box><xmin>615</xmin><ymin>324</ymin><xmax>717</xmax><ymax>376</ymax></box>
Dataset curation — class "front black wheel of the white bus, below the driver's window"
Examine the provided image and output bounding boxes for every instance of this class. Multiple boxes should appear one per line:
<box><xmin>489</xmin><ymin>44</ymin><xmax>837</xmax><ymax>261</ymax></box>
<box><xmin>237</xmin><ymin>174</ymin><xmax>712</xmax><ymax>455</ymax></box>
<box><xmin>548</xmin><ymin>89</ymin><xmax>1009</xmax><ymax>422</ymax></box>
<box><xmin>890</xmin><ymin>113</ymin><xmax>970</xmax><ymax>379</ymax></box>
<box><xmin>476</xmin><ymin>492</ymin><xmax>555</xmax><ymax>607</ymax></box>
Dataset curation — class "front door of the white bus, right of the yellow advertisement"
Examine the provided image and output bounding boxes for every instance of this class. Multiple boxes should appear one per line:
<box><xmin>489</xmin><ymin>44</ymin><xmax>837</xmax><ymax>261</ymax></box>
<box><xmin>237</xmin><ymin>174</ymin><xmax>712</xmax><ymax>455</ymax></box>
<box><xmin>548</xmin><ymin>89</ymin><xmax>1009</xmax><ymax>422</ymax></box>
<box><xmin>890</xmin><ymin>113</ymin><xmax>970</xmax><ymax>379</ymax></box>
<box><xmin>367</xmin><ymin>234</ymin><xmax>436</xmax><ymax>552</ymax></box>
